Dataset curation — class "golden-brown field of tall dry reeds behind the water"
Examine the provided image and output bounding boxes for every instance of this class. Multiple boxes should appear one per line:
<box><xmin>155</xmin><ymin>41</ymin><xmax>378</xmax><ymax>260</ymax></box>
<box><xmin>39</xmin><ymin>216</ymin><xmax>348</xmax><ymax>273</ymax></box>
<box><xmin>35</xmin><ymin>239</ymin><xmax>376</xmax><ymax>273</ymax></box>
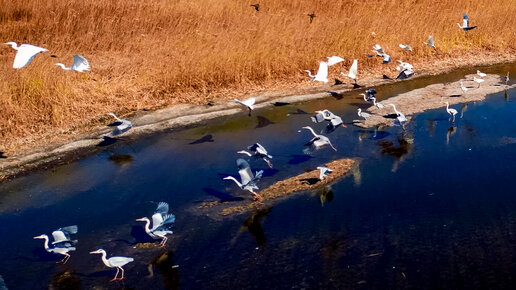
<box><xmin>0</xmin><ymin>0</ymin><xmax>516</xmax><ymax>154</ymax></box>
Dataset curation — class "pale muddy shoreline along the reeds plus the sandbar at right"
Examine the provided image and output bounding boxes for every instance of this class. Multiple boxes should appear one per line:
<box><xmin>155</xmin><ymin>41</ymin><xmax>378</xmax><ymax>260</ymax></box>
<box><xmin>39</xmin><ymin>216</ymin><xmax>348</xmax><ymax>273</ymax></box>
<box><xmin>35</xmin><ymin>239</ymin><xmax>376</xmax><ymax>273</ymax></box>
<box><xmin>0</xmin><ymin>58</ymin><xmax>515</xmax><ymax>182</ymax></box>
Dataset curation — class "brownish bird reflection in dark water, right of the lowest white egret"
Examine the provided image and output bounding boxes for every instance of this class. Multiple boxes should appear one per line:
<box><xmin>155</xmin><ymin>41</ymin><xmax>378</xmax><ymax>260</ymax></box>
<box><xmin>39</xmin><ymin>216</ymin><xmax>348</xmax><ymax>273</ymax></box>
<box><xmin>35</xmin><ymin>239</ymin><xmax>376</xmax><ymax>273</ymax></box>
<box><xmin>145</xmin><ymin>251</ymin><xmax>179</xmax><ymax>289</ymax></box>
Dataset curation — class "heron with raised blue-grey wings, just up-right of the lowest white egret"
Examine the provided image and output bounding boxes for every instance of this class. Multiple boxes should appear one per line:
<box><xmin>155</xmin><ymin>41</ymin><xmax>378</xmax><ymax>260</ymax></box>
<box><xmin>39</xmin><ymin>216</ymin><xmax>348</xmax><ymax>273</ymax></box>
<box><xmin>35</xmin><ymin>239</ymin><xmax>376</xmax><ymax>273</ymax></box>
<box><xmin>136</xmin><ymin>202</ymin><xmax>176</xmax><ymax>247</ymax></box>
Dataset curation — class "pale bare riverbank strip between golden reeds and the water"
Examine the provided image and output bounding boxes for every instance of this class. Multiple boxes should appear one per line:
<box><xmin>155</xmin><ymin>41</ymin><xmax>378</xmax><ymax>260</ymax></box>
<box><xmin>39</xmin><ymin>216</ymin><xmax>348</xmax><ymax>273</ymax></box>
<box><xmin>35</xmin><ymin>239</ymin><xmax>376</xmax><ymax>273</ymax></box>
<box><xmin>0</xmin><ymin>54</ymin><xmax>516</xmax><ymax>180</ymax></box>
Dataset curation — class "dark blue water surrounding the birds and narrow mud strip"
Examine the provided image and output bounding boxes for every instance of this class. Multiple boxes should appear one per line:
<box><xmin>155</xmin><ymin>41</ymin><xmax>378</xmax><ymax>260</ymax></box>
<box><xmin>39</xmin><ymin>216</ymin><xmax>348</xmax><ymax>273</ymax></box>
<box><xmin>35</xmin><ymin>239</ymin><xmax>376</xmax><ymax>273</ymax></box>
<box><xmin>0</xmin><ymin>65</ymin><xmax>516</xmax><ymax>289</ymax></box>
